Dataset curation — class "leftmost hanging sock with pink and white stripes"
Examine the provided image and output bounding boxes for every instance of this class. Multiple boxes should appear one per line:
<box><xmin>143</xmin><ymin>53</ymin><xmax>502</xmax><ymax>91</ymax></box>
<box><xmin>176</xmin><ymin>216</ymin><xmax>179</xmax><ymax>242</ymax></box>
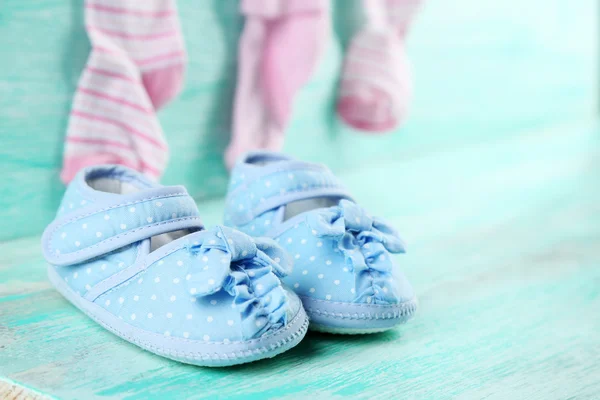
<box><xmin>61</xmin><ymin>0</ymin><xmax>185</xmax><ymax>183</ymax></box>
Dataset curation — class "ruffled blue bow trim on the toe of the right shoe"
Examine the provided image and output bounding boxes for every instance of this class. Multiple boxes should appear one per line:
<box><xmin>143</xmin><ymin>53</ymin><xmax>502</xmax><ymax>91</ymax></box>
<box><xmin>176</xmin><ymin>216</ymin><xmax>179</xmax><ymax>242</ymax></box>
<box><xmin>307</xmin><ymin>200</ymin><xmax>406</xmax><ymax>304</ymax></box>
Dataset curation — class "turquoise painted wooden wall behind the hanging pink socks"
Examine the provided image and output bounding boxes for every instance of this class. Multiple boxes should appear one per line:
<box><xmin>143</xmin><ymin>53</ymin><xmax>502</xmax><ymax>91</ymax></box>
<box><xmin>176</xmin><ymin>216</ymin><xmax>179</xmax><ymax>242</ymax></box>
<box><xmin>0</xmin><ymin>0</ymin><xmax>597</xmax><ymax>240</ymax></box>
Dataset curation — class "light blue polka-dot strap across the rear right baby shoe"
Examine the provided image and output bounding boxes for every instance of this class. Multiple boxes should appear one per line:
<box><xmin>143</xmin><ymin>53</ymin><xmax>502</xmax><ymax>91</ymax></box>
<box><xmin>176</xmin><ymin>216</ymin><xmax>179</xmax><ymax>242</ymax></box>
<box><xmin>227</xmin><ymin>161</ymin><xmax>351</xmax><ymax>225</ymax></box>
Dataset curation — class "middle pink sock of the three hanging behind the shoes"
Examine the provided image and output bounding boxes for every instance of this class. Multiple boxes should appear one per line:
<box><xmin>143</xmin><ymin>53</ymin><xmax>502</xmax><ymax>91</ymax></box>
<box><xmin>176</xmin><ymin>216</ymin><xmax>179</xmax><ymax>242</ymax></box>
<box><xmin>225</xmin><ymin>0</ymin><xmax>329</xmax><ymax>168</ymax></box>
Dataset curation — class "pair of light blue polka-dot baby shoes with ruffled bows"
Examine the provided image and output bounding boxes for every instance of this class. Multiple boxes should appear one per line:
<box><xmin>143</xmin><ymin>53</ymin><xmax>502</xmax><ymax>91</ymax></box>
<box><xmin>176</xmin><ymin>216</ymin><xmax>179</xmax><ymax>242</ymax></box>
<box><xmin>42</xmin><ymin>153</ymin><xmax>416</xmax><ymax>366</ymax></box>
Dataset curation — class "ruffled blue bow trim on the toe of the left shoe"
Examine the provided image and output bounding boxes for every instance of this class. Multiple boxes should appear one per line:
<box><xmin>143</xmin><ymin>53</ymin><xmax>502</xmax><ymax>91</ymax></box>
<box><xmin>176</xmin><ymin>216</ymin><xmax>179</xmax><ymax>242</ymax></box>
<box><xmin>186</xmin><ymin>226</ymin><xmax>292</xmax><ymax>339</ymax></box>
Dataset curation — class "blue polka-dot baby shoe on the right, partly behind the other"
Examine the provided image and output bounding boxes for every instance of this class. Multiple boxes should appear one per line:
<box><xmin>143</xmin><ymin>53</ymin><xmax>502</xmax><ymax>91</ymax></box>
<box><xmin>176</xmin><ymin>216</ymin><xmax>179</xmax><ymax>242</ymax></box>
<box><xmin>225</xmin><ymin>152</ymin><xmax>417</xmax><ymax>334</ymax></box>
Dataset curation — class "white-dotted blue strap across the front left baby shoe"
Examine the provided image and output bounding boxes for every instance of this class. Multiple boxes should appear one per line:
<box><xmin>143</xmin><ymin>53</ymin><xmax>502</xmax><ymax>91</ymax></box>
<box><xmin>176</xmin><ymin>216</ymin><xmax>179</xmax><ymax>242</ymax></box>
<box><xmin>42</xmin><ymin>186</ymin><xmax>203</xmax><ymax>265</ymax></box>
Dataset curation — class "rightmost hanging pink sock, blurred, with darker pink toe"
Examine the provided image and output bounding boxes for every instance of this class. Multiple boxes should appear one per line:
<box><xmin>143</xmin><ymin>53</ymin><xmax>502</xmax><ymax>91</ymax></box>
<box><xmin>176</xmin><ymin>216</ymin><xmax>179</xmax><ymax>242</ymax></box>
<box><xmin>337</xmin><ymin>0</ymin><xmax>419</xmax><ymax>133</ymax></box>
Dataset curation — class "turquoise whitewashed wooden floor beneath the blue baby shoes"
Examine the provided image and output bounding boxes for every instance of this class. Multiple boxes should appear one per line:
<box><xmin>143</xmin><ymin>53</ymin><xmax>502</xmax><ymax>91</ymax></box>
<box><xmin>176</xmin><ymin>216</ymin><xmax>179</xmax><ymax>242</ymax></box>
<box><xmin>0</xmin><ymin>122</ymin><xmax>600</xmax><ymax>399</ymax></box>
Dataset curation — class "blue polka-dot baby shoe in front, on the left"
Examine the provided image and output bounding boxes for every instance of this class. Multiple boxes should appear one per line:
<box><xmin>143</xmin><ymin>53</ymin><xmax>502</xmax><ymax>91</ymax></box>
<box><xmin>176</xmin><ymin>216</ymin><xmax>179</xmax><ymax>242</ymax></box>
<box><xmin>42</xmin><ymin>166</ymin><xmax>308</xmax><ymax>366</ymax></box>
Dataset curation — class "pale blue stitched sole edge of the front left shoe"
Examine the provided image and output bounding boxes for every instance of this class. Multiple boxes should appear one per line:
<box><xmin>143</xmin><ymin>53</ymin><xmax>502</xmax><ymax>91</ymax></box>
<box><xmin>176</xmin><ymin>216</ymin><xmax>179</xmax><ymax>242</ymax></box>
<box><xmin>48</xmin><ymin>266</ymin><xmax>308</xmax><ymax>367</ymax></box>
